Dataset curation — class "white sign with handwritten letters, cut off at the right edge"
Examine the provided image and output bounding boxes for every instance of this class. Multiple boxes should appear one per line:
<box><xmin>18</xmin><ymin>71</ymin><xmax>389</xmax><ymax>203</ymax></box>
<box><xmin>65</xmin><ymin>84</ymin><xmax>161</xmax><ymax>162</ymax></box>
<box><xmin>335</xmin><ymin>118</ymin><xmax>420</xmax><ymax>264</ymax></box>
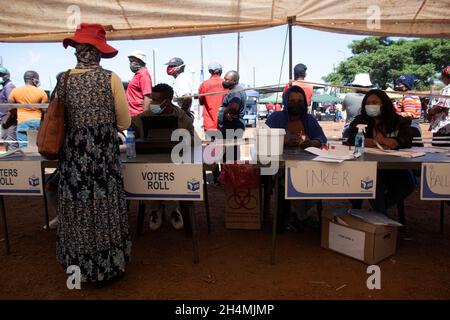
<box><xmin>420</xmin><ymin>162</ymin><xmax>450</xmax><ymax>201</ymax></box>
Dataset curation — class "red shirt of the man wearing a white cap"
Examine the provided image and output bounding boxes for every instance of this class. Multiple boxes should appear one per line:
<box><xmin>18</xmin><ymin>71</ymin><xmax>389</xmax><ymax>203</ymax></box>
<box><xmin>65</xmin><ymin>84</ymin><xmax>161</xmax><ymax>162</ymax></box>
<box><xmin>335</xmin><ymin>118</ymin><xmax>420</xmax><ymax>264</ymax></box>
<box><xmin>127</xmin><ymin>67</ymin><xmax>152</xmax><ymax>117</ymax></box>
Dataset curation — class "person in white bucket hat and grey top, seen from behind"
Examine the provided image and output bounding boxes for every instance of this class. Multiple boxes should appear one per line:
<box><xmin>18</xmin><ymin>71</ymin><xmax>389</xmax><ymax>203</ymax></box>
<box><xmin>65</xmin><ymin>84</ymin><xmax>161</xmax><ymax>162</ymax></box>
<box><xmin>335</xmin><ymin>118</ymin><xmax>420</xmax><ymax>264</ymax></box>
<box><xmin>342</xmin><ymin>73</ymin><xmax>372</xmax><ymax>141</ymax></box>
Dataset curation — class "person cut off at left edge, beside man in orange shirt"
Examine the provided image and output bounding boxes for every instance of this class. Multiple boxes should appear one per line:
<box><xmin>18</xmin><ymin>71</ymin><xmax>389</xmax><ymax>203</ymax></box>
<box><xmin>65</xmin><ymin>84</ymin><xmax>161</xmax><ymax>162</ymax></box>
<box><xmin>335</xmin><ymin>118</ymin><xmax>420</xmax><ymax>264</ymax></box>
<box><xmin>0</xmin><ymin>67</ymin><xmax>19</xmax><ymax>151</ymax></box>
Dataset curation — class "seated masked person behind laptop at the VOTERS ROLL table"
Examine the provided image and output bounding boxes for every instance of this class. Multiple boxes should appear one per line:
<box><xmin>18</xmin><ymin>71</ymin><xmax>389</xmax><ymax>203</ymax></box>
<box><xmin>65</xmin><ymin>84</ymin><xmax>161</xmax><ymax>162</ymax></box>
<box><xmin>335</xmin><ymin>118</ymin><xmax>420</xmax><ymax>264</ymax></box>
<box><xmin>131</xmin><ymin>83</ymin><xmax>194</xmax><ymax>231</ymax></box>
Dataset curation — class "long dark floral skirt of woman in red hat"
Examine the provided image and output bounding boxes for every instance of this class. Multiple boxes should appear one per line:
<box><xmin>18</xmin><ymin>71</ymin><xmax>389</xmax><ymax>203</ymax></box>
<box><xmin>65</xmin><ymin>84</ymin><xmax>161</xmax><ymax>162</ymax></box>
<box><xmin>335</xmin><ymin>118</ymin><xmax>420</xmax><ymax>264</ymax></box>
<box><xmin>56</xmin><ymin>124</ymin><xmax>131</xmax><ymax>282</ymax></box>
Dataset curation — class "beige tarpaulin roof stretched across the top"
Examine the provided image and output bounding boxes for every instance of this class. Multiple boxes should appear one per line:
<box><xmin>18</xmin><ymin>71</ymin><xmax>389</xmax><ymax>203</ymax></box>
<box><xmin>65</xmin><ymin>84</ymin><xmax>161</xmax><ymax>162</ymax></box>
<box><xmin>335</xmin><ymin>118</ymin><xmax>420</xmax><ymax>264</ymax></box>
<box><xmin>0</xmin><ymin>0</ymin><xmax>450</xmax><ymax>42</ymax></box>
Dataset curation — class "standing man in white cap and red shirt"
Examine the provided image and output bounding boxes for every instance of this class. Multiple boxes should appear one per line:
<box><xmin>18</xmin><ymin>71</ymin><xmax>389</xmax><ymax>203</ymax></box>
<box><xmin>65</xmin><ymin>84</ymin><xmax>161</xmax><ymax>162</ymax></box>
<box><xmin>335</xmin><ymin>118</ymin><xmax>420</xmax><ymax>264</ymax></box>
<box><xmin>127</xmin><ymin>50</ymin><xmax>152</xmax><ymax>117</ymax></box>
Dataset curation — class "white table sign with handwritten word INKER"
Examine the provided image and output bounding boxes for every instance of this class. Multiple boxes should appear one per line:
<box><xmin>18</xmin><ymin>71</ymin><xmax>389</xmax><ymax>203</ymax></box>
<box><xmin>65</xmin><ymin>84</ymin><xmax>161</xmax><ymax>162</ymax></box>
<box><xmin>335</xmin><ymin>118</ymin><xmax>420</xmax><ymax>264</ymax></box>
<box><xmin>285</xmin><ymin>161</ymin><xmax>377</xmax><ymax>199</ymax></box>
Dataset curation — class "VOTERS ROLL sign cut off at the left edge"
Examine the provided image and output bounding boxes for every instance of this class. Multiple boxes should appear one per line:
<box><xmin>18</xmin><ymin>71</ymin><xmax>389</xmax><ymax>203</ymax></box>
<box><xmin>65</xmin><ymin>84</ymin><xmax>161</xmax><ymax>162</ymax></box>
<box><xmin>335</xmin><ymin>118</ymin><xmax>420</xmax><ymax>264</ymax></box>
<box><xmin>0</xmin><ymin>161</ymin><xmax>43</xmax><ymax>196</ymax></box>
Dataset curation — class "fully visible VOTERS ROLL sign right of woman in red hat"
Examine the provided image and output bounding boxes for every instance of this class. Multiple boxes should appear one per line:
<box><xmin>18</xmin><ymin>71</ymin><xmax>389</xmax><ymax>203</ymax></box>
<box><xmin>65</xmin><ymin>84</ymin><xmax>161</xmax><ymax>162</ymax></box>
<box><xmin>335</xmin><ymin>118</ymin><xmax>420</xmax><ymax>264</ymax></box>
<box><xmin>123</xmin><ymin>163</ymin><xmax>203</xmax><ymax>201</ymax></box>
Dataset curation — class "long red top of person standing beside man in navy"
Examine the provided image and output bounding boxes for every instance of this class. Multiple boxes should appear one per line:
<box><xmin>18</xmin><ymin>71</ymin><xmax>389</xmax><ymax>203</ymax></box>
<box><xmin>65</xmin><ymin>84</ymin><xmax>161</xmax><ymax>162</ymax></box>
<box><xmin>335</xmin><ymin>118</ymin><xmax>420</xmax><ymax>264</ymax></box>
<box><xmin>198</xmin><ymin>74</ymin><xmax>225</xmax><ymax>131</ymax></box>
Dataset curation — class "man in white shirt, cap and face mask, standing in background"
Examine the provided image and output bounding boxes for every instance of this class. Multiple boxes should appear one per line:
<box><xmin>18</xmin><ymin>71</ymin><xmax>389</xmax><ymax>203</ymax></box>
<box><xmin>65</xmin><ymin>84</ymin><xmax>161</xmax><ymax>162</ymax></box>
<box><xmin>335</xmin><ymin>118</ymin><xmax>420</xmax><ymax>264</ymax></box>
<box><xmin>165</xmin><ymin>57</ymin><xmax>194</xmax><ymax>118</ymax></box>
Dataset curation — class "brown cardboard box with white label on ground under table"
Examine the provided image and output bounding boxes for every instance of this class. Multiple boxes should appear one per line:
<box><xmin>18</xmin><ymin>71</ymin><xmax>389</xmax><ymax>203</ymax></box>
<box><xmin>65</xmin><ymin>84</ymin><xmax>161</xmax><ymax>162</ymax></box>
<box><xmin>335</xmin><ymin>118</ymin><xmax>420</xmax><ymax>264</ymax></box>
<box><xmin>322</xmin><ymin>209</ymin><xmax>398</xmax><ymax>265</ymax></box>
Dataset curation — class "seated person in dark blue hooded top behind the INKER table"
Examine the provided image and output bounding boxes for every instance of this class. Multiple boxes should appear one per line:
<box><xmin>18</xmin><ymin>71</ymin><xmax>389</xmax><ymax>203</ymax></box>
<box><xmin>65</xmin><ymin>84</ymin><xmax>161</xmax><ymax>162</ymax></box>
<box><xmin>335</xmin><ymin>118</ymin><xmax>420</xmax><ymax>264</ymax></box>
<box><xmin>266</xmin><ymin>86</ymin><xmax>327</xmax><ymax>231</ymax></box>
